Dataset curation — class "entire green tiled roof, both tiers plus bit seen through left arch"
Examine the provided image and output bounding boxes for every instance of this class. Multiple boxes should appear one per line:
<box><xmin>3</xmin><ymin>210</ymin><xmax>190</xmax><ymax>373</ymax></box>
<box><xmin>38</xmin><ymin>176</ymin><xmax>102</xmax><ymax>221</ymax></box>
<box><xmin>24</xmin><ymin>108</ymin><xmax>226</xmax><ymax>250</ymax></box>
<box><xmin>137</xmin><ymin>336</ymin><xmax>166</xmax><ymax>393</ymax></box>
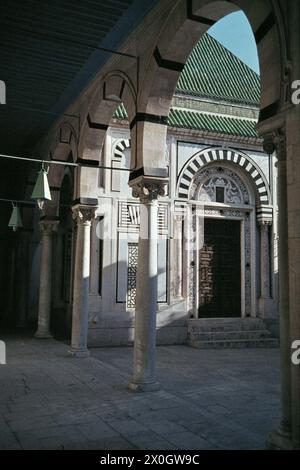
<box><xmin>114</xmin><ymin>34</ymin><xmax>260</xmax><ymax>137</ymax></box>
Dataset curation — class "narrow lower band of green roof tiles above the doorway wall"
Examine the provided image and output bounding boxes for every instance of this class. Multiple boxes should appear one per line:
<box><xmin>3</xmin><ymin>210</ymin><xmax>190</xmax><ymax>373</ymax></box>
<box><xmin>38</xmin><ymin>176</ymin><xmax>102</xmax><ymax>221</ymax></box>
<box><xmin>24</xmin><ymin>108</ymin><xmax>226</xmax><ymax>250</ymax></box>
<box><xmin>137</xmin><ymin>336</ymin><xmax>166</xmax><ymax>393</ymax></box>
<box><xmin>168</xmin><ymin>108</ymin><xmax>258</xmax><ymax>137</ymax></box>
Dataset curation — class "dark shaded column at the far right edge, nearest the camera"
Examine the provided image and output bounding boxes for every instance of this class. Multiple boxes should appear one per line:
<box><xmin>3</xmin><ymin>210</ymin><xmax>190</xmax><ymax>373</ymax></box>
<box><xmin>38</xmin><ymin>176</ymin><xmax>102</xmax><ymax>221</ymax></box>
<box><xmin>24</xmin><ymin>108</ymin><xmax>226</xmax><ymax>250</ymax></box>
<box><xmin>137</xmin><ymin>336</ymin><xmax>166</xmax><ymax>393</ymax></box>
<box><xmin>267</xmin><ymin>134</ymin><xmax>291</xmax><ymax>448</ymax></box>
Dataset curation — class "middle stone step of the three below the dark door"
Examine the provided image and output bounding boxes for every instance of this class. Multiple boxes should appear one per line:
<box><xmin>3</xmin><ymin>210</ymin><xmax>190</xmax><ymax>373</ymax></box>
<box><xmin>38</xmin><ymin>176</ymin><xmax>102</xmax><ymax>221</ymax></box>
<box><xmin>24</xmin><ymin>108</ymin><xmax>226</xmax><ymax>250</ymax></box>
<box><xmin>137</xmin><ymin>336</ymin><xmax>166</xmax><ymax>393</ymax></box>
<box><xmin>188</xmin><ymin>330</ymin><xmax>272</xmax><ymax>341</ymax></box>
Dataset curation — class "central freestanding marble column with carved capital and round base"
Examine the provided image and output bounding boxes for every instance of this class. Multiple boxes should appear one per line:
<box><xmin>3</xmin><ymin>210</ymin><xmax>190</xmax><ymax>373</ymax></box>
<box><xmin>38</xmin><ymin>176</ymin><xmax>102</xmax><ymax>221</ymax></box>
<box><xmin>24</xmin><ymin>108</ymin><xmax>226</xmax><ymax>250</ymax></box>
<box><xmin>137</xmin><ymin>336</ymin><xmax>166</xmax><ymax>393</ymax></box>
<box><xmin>129</xmin><ymin>178</ymin><xmax>164</xmax><ymax>392</ymax></box>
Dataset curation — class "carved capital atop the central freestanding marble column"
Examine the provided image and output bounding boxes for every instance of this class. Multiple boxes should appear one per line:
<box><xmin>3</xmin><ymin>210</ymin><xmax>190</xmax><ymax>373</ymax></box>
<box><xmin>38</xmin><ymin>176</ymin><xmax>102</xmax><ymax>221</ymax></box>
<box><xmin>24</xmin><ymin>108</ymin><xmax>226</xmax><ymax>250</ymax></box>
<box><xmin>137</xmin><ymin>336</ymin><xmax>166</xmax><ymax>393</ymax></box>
<box><xmin>131</xmin><ymin>176</ymin><xmax>167</xmax><ymax>203</ymax></box>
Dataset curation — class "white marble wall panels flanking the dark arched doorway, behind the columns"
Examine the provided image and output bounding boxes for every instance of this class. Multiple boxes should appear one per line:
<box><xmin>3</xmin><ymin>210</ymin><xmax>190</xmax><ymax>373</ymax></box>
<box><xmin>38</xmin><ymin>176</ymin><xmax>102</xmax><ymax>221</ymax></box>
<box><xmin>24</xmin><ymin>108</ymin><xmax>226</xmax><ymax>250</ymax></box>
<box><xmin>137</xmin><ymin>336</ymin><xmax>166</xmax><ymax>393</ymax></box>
<box><xmin>89</xmin><ymin>128</ymin><xmax>277</xmax><ymax>345</ymax></box>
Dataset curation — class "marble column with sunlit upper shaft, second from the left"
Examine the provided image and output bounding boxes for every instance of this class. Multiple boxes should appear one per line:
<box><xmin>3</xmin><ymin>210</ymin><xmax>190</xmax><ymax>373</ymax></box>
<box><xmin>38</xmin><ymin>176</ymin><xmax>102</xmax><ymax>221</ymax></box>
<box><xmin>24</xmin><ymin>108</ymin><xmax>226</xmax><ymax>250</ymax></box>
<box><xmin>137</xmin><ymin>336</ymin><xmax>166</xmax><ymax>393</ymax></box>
<box><xmin>70</xmin><ymin>204</ymin><xmax>97</xmax><ymax>357</ymax></box>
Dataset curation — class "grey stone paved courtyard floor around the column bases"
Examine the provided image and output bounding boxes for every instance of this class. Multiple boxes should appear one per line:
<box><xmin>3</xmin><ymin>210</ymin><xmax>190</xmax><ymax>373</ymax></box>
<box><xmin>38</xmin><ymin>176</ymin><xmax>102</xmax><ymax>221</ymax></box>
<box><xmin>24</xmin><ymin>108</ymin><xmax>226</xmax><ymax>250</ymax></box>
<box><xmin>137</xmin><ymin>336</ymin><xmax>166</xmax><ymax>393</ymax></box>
<box><xmin>0</xmin><ymin>338</ymin><xmax>279</xmax><ymax>450</ymax></box>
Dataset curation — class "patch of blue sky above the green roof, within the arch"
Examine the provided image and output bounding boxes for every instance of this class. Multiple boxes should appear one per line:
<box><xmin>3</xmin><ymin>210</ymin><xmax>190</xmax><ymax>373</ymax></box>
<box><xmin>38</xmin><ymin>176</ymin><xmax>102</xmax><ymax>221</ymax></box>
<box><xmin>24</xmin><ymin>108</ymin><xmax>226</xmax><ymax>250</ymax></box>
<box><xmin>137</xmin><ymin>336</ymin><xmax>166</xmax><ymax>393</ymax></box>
<box><xmin>208</xmin><ymin>11</ymin><xmax>259</xmax><ymax>73</ymax></box>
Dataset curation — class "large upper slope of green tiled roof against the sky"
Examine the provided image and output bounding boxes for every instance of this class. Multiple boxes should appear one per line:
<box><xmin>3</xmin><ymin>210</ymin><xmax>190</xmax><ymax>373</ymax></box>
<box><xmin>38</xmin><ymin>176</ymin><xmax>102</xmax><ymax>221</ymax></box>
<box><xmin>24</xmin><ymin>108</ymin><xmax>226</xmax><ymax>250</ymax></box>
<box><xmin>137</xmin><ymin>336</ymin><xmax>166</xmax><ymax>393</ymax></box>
<box><xmin>176</xmin><ymin>34</ymin><xmax>260</xmax><ymax>104</ymax></box>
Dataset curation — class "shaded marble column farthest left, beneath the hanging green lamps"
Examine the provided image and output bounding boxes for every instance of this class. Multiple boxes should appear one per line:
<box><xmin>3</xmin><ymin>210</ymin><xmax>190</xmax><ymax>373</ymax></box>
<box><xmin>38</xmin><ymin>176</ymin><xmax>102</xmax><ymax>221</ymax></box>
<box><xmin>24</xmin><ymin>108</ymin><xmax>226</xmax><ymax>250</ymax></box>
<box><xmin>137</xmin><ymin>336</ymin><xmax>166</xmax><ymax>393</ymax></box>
<box><xmin>35</xmin><ymin>219</ymin><xmax>59</xmax><ymax>339</ymax></box>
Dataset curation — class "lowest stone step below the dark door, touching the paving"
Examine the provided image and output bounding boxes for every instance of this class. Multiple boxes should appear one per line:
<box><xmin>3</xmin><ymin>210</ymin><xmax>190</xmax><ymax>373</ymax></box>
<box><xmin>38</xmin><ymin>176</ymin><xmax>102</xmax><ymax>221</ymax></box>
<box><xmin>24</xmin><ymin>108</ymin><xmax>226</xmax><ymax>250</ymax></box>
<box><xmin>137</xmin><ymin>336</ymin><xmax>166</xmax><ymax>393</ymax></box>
<box><xmin>188</xmin><ymin>338</ymin><xmax>279</xmax><ymax>349</ymax></box>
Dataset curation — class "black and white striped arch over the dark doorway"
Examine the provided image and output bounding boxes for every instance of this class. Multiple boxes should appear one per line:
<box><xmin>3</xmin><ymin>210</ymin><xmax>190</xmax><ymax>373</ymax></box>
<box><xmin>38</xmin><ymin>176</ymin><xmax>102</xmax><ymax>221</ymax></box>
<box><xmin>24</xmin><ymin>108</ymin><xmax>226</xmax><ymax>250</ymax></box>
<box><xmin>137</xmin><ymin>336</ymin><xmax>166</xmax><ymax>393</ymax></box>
<box><xmin>178</xmin><ymin>149</ymin><xmax>269</xmax><ymax>204</ymax></box>
